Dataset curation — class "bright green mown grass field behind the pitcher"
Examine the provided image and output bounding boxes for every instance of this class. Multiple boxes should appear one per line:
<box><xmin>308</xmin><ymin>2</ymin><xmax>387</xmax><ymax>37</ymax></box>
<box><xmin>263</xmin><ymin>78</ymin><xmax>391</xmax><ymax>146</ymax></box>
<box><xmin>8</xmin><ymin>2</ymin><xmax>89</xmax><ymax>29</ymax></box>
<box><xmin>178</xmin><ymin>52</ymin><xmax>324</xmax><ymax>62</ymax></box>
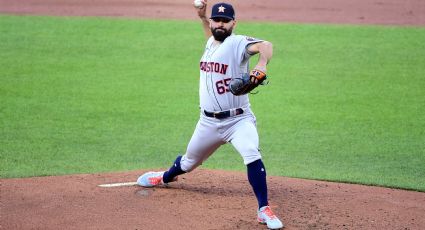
<box><xmin>0</xmin><ymin>16</ymin><xmax>425</xmax><ymax>191</ymax></box>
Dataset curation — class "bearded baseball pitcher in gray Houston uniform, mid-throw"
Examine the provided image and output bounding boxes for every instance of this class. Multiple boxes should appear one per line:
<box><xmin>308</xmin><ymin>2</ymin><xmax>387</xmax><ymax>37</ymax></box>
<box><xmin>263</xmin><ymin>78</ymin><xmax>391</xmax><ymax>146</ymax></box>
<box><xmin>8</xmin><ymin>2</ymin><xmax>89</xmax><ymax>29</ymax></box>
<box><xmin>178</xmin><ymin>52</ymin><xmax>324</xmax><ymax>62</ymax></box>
<box><xmin>137</xmin><ymin>0</ymin><xmax>283</xmax><ymax>229</ymax></box>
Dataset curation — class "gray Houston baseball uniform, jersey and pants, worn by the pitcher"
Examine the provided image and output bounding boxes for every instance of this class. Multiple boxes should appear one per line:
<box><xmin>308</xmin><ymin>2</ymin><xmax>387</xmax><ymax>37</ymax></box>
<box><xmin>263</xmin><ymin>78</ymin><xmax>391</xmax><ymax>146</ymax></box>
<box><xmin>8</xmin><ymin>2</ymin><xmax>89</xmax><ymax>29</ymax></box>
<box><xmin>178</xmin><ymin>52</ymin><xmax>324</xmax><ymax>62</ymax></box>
<box><xmin>181</xmin><ymin>34</ymin><xmax>262</xmax><ymax>172</ymax></box>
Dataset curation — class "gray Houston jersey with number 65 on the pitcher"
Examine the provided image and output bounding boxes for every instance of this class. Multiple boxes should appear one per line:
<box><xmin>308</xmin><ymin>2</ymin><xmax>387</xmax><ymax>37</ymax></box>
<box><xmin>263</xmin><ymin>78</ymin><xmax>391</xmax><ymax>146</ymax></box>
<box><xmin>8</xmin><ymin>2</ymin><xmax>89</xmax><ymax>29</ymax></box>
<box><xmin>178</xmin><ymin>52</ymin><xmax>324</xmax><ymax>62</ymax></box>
<box><xmin>199</xmin><ymin>34</ymin><xmax>262</xmax><ymax>112</ymax></box>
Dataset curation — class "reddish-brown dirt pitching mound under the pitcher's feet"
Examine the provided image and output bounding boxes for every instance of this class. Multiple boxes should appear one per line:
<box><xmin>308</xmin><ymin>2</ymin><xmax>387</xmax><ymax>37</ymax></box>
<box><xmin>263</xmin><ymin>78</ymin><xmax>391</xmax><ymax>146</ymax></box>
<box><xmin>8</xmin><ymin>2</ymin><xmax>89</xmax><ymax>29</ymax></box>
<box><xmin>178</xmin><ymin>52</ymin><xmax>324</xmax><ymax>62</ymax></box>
<box><xmin>0</xmin><ymin>169</ymin><xmax>425</xmax><ymax>229</ymax></box>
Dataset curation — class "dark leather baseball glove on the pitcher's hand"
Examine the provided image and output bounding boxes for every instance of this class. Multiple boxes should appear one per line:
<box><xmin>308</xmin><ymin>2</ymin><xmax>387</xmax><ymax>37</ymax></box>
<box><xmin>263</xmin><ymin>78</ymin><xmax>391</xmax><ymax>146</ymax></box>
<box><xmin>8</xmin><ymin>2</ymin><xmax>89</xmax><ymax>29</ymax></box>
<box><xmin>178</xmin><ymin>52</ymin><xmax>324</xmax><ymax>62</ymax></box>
<box><xmin>229</xmin><ymin>69</ymin><xmax>267</xmax><ymax>96</ymax></box>
